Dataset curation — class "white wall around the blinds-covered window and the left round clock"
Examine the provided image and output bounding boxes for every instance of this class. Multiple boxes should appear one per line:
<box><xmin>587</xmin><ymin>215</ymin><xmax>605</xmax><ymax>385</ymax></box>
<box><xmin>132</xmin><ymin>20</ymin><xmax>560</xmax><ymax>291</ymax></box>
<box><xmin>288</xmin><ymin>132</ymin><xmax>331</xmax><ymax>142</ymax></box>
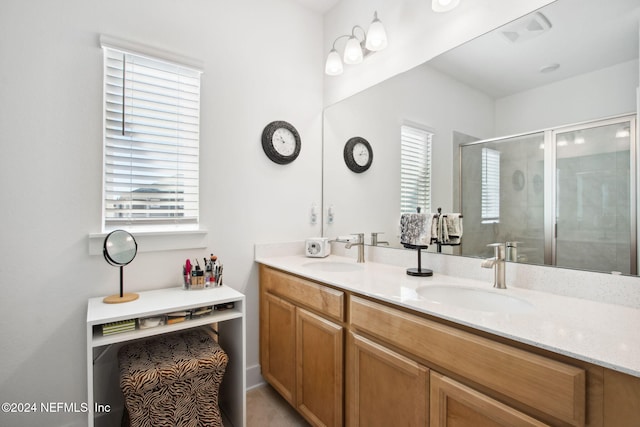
<box><xmin>0</xmin><ymin>0</ymin><xmax>323</xmax><ymax>426</ymax></box>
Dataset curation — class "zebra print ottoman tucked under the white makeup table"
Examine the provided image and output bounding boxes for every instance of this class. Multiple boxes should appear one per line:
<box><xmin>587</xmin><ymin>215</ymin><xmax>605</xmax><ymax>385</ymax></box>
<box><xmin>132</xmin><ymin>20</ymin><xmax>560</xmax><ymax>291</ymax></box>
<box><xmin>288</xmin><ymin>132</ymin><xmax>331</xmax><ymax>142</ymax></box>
<box><xmin>118</xmin><ymin>329</ymin><xmax>229</xmax><ymax>427</ymax></box>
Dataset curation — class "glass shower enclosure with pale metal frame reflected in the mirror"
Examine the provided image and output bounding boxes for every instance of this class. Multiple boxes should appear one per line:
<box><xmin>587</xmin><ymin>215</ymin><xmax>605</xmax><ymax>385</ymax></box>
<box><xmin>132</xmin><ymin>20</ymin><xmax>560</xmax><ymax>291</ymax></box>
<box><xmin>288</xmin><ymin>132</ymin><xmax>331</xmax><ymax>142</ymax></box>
<box><xmin>460</xmin><ymin>116</ymin><xmax>637</xmax><ymax>274</ymax></box>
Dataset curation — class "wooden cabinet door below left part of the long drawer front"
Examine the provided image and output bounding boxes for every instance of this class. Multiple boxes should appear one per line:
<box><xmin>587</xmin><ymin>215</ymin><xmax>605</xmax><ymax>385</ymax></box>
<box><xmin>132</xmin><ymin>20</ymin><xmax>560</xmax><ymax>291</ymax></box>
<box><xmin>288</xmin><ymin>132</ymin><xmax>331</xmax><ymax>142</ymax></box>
<box><xmin>347</xmin><ymin>334</ymin><xmax>429</xmax><ymax>427</ymax></box>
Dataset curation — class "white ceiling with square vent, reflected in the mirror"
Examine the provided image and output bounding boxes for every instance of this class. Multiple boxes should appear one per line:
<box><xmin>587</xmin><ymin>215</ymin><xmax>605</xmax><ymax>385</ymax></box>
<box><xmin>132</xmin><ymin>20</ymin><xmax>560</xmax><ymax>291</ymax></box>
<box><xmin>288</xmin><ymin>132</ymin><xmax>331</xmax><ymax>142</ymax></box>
<box><xmin>428</xmin><ymin>0</ymin><xmax>640</xmax><ymax>98</ymax></box>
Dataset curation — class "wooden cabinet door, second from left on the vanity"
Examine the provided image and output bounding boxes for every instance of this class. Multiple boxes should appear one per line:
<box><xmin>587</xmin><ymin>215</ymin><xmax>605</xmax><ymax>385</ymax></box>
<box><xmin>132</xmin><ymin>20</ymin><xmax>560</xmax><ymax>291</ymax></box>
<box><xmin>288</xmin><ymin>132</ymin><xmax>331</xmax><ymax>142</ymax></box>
<box><xmin>296</xmin><ymin>308</ymin><xmax>343</xmax><ymax>426</ymax></box>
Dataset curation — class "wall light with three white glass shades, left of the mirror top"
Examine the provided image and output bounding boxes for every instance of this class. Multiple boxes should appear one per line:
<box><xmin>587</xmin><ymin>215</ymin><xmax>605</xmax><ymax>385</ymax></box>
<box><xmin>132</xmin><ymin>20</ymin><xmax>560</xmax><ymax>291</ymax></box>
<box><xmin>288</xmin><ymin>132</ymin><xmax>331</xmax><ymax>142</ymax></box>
<box><xmin>324</xmin><ymin>12</ymin><xmax>387</xmax><ymax>76</ymax></box>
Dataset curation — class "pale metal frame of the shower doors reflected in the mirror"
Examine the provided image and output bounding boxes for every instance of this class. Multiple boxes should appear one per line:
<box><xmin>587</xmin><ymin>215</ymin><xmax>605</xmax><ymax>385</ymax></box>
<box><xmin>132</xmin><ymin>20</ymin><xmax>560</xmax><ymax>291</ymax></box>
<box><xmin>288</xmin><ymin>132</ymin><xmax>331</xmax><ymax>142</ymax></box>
<box><xmin>458</xmin><ymin>113</ymin><xmax>640</xmax><ymax>275</ymax></box>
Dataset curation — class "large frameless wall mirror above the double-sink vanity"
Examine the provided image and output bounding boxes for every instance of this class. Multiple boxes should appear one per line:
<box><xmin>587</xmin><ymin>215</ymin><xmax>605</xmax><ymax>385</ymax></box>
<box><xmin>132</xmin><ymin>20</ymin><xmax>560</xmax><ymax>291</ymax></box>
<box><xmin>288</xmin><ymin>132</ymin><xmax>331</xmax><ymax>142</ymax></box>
<box><xmin>323</xmin><ymin>0</ymin><xmax>640</xmax><ymax>273</ymax></box>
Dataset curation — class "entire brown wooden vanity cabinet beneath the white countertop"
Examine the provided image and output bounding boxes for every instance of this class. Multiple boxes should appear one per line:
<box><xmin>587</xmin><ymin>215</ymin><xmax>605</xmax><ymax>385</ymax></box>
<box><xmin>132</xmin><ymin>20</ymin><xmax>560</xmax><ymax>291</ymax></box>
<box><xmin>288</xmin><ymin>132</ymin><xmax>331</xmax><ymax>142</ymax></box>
<box><xmin>260</xmin><ymin>265</ymin><xmax>640</xmax><ymax>427</ymax></box>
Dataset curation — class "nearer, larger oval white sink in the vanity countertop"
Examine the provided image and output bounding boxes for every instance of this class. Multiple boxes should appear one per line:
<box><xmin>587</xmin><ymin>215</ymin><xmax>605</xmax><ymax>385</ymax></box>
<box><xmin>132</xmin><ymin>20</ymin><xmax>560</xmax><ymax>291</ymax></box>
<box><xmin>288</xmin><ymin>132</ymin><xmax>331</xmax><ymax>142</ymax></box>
<box><xmin>416</xmin><ymin>285</ymin><xmax>533</xmax><ymax>313</ymax></box>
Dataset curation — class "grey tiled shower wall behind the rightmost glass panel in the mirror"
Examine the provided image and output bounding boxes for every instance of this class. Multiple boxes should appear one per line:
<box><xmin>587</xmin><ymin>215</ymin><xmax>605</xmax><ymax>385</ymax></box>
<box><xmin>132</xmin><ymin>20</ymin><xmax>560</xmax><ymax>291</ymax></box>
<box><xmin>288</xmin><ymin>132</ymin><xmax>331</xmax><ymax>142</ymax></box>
<box><xmin>556</xmin><ymin>125</ymin><xmax>631</xmax><ymax>273</ymax></box>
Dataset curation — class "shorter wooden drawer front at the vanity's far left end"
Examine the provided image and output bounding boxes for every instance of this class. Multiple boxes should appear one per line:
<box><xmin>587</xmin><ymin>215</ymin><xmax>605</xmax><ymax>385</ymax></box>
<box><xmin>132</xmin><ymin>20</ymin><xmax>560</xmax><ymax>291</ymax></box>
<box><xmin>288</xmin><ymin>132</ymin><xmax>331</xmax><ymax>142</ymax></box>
<box><xmin>260</xmin><ymin>265</ymin><xmax>344</xmax><ymax>322</ymax></box>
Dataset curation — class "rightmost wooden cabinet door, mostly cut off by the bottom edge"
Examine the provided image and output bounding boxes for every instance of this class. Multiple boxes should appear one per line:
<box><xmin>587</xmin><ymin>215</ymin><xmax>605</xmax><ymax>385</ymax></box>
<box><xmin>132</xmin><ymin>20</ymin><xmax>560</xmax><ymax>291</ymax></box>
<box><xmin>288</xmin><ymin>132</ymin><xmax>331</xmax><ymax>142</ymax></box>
<box><xmin>430</xmin><ymin>372</ymin><xmax>547</xmax><ymax>427</ymax></box>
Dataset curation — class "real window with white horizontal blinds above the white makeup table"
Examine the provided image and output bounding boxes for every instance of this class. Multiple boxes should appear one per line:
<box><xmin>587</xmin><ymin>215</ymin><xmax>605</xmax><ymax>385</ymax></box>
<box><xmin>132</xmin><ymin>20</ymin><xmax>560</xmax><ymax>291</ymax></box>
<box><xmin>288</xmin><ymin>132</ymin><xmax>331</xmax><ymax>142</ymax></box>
<box><xmin>102</xmin><ymin>42</ymin><xmax>201</xmax><ymax>231</ymax></box>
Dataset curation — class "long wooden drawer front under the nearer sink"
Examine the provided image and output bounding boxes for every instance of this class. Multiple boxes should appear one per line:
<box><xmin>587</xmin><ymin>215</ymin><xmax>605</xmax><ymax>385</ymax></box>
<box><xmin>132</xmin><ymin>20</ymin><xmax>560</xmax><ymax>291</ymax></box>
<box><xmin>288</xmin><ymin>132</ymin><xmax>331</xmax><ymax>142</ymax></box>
<box><xmin>350</xmin><ymin>297</ymin><xmax>586</xmax><ymax>426</ymax></box>
